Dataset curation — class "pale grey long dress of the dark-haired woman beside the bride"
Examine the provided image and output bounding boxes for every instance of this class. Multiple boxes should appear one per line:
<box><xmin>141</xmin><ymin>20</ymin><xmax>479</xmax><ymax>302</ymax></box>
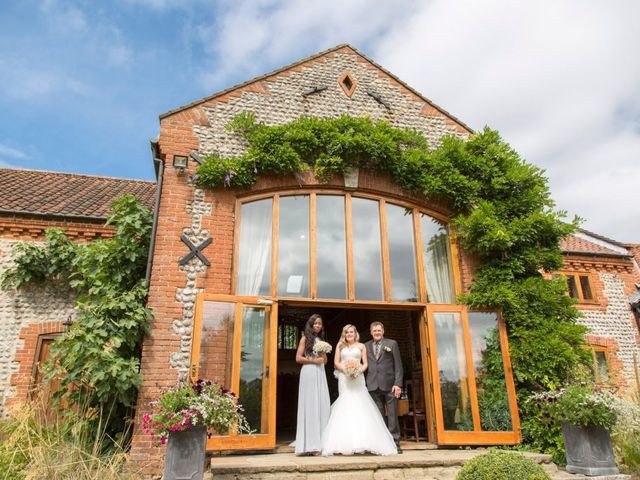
<box><xmin>294</xmin><ymin>338</ymin><xmax>331</xmax><ymax>455</ymax></box>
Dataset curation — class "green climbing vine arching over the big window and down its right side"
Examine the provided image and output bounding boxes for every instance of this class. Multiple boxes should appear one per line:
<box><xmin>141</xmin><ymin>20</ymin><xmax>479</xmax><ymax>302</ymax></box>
<box><xmin>197</xmin><ymin>114</ymin><xmax>585</xmax><ymax>458</ymax></box>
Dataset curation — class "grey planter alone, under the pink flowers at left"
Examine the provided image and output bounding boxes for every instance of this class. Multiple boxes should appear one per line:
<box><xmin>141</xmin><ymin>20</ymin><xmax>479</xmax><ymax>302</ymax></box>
<box><xmin>162</xmin><ymin>427</ymin><xmax>207</xmax><ymax>480</ymax></box>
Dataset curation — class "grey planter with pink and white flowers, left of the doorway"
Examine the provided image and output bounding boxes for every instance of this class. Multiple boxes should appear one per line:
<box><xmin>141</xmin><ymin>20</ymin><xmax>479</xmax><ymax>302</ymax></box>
<box><xmin>142</xmin><ymin>380</ymin><xmax>250</xmax><ymax>480</ymax></box>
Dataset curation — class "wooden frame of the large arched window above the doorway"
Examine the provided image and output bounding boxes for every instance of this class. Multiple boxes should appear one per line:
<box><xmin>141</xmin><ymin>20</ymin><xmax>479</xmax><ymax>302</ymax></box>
<box><xmin>231</xmin><ymin>188</ymin><xmax>462</xmax><ymax>305</ymax></box>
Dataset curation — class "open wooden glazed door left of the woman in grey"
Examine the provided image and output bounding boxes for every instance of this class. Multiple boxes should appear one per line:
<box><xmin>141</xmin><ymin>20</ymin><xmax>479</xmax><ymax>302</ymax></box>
<box><xmin>191</xmin><ymin>294</ymin><xmax>277</xmax><ymax>450</ymax></box>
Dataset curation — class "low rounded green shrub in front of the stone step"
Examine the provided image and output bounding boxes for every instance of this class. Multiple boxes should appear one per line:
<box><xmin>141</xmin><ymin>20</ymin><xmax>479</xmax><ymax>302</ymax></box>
<box><xmin>456</xmin><ymin>451</ymin><xmax>551</xmax><ymax>480</ymax></box>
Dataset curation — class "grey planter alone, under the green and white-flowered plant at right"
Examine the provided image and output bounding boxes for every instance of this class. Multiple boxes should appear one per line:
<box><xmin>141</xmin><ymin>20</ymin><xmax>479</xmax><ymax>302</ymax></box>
<box><xmin>562</xmin><ymin>423</ymin><xmax>619</xmax><ymax>477</ymax></box>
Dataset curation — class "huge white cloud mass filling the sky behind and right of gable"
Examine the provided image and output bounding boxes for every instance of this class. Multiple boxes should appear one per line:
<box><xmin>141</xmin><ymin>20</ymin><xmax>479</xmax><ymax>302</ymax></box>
<box><xmin>200</xmin><ymin>0</ymin><xmax>640</xmax><ymax>241</ymax></box>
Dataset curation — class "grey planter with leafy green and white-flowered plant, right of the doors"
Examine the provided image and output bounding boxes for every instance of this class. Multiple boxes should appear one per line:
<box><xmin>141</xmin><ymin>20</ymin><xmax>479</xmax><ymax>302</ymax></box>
<box><xmin>534</xmin><ymin>385</ymin><xmax>619</xmax><ymax>476</ymax></box>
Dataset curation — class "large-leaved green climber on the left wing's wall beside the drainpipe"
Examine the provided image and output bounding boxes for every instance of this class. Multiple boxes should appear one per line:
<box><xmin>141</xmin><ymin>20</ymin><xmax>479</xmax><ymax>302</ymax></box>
<box><xmin>2</xmin><ymin>195</ymin><xmax>152</xmax><ymax>433</ymax></box>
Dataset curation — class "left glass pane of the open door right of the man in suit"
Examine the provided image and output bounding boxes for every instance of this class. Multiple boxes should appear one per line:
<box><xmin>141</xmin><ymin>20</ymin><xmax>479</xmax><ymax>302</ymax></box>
<box><xmin>433</xmin><ymin>312</ymin><xmax>473</xmax><ymax>432</ymax></box>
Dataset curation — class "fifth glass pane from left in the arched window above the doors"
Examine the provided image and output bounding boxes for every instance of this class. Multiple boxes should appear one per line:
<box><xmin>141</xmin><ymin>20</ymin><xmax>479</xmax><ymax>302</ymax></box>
<box><xmin>386</xmin><ymin>203</ymin><xmax>418</xmax><ymax>302</ymax></box>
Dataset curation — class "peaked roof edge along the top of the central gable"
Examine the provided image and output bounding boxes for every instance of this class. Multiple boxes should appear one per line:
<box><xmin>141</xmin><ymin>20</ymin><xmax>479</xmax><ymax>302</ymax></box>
<box><xmin>159</xmin><ymin>43</ymin><xmax>474</xmax><ymax>133</ymax></box>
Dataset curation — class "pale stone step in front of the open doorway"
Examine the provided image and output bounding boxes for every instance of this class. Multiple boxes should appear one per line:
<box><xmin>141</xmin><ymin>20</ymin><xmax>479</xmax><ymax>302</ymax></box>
<box><xmin>210</xmin><ymin>448</ymin><xmax>616</xmax><ymax>480</ymax></box>
